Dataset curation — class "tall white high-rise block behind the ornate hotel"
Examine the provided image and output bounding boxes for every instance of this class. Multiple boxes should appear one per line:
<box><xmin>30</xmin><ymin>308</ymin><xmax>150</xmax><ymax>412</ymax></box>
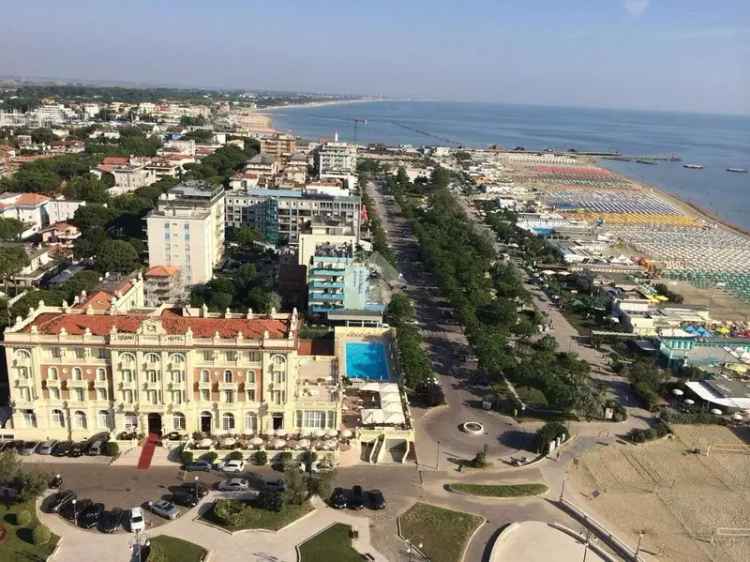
<box><xmin>146</xmin><ymin>181</ymin><xmax>224</xmax><ymax>286</ymax></box>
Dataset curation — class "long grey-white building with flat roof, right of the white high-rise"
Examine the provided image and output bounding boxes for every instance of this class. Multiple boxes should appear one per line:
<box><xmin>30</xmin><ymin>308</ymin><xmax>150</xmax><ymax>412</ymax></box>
<box><xmin>226</xmin><ymin>188</ymin><xmax>362</xmax><ymax>246</ymax></box>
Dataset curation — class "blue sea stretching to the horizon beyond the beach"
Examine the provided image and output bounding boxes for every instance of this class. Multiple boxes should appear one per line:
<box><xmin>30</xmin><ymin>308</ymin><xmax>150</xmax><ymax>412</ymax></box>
<box><xmin>271</xmin><ymin>101</ymin><xmax>750</xmax><ymax>229</ymax></box>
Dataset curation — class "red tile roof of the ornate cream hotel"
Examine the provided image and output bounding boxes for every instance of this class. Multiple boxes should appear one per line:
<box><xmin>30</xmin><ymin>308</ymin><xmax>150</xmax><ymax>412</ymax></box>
<box><xmin>23</xmin><ymin>310</ymin><xmax>289</xmax><ymax>338</ymax></box>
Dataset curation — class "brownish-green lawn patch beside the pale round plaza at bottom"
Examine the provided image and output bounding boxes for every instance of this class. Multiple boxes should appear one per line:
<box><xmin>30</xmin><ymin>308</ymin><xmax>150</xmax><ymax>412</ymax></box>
<box><xmin>399</xmin><ymin>503</ymin><xmax>482</xmax><ymax>562</ymax></box>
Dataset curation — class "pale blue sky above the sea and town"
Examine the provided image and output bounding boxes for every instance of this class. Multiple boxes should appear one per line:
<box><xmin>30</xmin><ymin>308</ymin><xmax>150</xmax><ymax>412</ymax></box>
<box><xmin>0</xmin><ymin>0</ymin><xmax>750</xmax><ymax>114</ymax></box>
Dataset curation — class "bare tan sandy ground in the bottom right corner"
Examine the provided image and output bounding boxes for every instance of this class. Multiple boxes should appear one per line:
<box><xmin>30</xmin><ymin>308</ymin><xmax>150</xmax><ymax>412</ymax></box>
<box><xmin>568</xmin><ymin>426</ymin><xmax>750</xmax><ymax>562</ymax></box>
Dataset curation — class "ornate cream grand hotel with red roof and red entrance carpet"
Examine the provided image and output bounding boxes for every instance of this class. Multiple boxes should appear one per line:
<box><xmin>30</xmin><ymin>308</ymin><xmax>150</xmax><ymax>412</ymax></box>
<box><xmin>3</xmin><ymin>304</ymin><xmax>342</xmax><ymax>439</ymax></box>
